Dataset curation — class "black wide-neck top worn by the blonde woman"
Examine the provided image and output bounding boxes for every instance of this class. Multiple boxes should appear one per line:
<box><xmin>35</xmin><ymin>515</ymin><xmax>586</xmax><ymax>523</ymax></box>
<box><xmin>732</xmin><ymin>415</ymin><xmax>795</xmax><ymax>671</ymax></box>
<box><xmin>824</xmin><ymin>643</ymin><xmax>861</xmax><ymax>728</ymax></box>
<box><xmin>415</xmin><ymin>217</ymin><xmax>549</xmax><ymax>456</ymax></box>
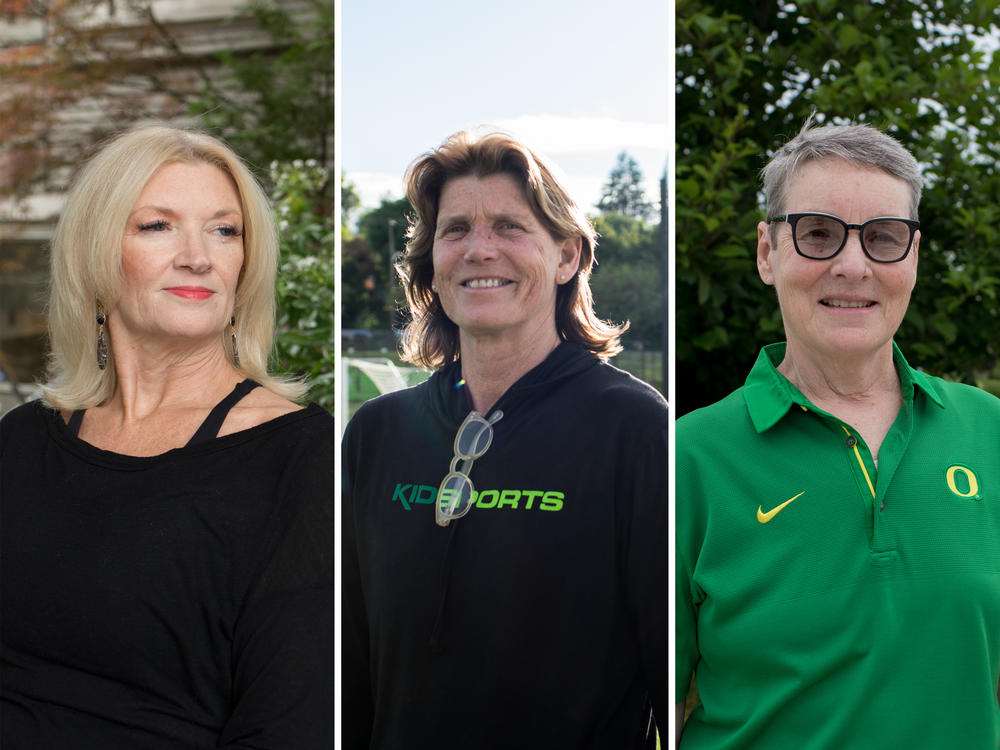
<box><xmin>0</xmin><ymin>402</ymin><xmax>334</xmax><ymax>750</ymax></box>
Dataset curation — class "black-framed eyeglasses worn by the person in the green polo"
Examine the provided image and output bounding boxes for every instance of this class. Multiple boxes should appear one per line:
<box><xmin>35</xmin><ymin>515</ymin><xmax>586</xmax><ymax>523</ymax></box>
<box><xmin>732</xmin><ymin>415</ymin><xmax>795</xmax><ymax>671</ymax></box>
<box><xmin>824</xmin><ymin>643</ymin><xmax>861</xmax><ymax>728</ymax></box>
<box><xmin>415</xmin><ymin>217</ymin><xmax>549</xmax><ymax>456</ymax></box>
<box><xmin>771</xmin><ymin>212</ymin><xmax>920</xmax><ymax>263</ymax></box>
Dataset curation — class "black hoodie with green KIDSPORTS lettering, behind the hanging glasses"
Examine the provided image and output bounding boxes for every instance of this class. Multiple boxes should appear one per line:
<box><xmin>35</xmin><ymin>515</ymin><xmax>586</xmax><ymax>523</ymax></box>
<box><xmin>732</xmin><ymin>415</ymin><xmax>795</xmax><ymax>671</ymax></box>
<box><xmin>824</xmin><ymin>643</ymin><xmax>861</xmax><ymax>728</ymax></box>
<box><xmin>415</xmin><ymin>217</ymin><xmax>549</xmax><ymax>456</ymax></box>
<box><xmin>341</xmin><ymin>343</ymin><xmax>667</xmax><ymax>750</ymax></box>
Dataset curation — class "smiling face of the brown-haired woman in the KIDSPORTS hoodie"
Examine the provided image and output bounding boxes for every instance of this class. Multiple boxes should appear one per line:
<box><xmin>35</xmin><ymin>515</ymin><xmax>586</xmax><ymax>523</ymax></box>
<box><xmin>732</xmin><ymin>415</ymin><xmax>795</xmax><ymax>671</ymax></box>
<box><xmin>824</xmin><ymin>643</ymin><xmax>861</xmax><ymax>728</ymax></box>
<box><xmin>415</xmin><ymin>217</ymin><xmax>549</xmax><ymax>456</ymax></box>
<box><xmin>433</xmin><ymin>174</ymin><xmax>581</xmax><ymax>352</ymax></box>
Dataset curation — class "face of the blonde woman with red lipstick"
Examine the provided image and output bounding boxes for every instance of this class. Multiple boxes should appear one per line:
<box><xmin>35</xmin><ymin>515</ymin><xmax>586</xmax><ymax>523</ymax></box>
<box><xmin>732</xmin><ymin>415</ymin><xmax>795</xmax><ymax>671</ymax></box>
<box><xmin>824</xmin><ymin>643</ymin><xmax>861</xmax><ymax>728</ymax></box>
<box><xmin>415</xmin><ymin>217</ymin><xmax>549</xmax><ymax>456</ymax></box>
<box><xmin>109</xmin><ymin>162</ymin><xmax>243</xmax><ymax>350</ymax></box>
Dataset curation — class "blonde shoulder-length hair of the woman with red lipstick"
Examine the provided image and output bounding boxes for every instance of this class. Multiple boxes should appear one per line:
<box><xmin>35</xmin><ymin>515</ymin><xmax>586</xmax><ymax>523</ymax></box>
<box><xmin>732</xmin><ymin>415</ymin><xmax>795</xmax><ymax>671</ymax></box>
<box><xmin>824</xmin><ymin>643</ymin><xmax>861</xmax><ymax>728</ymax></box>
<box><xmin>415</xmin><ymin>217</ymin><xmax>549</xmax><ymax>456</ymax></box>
<box><xmin>42</xmin><ymin>125</ymin><xmax>307</xmax><ymax>409</ymax></box>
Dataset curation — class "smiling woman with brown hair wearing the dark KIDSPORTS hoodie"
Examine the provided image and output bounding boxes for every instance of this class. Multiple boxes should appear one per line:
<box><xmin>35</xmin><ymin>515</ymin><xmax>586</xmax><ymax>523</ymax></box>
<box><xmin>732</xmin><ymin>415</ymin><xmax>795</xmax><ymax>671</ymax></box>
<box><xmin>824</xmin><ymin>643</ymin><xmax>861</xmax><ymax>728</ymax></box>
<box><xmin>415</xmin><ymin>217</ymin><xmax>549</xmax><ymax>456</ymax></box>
<box><xmin>343</xmin><ymin>132</ymin><xmax>667</xmax><ymax>748</ymax></box>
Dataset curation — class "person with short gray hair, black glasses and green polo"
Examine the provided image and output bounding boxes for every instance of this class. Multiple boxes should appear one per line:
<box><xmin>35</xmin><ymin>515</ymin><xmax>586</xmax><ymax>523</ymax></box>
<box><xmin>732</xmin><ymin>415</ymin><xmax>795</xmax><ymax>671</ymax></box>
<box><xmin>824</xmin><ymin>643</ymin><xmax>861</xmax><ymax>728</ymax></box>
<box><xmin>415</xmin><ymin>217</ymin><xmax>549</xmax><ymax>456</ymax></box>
<box><xmin>676</xmin><ymin>122</ymin><xmax>1000</xmax><ymax>750</ymax></box>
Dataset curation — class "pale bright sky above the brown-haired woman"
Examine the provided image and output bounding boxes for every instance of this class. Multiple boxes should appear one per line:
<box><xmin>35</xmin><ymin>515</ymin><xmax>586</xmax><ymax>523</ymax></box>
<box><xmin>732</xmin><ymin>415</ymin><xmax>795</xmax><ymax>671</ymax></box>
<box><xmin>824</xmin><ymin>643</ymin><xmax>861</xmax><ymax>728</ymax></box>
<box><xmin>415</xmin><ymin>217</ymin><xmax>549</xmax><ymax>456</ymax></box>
<box><xmin>340</xmin><ymin>0</ymin><xmax>673</xmax><ymax>213</ymax></box>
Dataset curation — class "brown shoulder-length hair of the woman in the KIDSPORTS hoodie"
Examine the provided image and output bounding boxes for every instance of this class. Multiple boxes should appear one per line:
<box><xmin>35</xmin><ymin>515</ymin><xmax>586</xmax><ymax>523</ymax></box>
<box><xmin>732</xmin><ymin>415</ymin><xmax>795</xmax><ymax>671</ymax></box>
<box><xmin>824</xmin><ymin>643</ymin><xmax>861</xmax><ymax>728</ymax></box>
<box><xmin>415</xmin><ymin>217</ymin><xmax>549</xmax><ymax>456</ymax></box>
<box><xmin>396</xmin><ymin>131</ymin><xmax>628</xmax><ymax>370</ymax></box>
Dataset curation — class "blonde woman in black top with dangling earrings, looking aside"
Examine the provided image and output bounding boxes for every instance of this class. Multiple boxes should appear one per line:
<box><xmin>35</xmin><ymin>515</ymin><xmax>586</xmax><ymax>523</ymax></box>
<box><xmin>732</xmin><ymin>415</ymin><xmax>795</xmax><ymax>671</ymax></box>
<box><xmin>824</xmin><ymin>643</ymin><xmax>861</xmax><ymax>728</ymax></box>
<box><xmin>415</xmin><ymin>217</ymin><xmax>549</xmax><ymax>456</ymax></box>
<box><xmin>0</xmin><ymin>127</ymin><xmax>333</xmax><ymax>750</ymax></box>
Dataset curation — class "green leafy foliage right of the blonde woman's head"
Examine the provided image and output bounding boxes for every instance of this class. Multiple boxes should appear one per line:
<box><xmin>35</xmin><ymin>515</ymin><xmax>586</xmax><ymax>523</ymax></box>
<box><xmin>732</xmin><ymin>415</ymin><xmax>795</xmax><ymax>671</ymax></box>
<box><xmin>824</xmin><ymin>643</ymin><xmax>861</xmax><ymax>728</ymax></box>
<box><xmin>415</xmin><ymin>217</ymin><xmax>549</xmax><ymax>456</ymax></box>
<box><xmin>181</xmin><ymin>0</ymin><xmax>340</xmax><ymax>411</ymax></box>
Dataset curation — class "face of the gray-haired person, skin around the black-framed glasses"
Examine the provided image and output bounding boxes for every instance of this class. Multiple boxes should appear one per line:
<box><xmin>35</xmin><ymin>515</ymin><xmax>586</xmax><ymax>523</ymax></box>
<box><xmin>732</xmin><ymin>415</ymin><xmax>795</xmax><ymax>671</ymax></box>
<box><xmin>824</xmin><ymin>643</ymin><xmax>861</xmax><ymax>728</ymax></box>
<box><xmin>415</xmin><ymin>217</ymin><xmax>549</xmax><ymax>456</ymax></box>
<box><xmin>757</xmin><ymin>158</ymin><xmax>920</xmax><ymax>366</ymax></box>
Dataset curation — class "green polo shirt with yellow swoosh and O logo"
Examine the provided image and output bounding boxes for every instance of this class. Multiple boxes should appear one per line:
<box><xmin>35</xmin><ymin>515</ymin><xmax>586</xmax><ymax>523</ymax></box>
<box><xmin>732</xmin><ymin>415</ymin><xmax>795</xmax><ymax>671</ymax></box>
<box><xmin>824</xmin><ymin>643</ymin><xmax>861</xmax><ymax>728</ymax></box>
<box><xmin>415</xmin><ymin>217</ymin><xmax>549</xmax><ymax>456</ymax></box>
<box><xmin>676</xmin><ymin>344</ymin><xmax>1000</xmax><ymax>750</ymax></box>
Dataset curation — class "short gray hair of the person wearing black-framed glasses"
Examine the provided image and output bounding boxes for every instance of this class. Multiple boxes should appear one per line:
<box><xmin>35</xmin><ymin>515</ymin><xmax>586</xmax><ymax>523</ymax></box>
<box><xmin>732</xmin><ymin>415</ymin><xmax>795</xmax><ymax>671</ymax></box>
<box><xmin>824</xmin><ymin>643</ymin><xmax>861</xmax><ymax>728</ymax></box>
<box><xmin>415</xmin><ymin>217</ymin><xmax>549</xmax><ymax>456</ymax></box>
<box><xmin>761</xmin><ymin>113</ymin><xmax>923</xmax><ymax>221</ymax></box>
